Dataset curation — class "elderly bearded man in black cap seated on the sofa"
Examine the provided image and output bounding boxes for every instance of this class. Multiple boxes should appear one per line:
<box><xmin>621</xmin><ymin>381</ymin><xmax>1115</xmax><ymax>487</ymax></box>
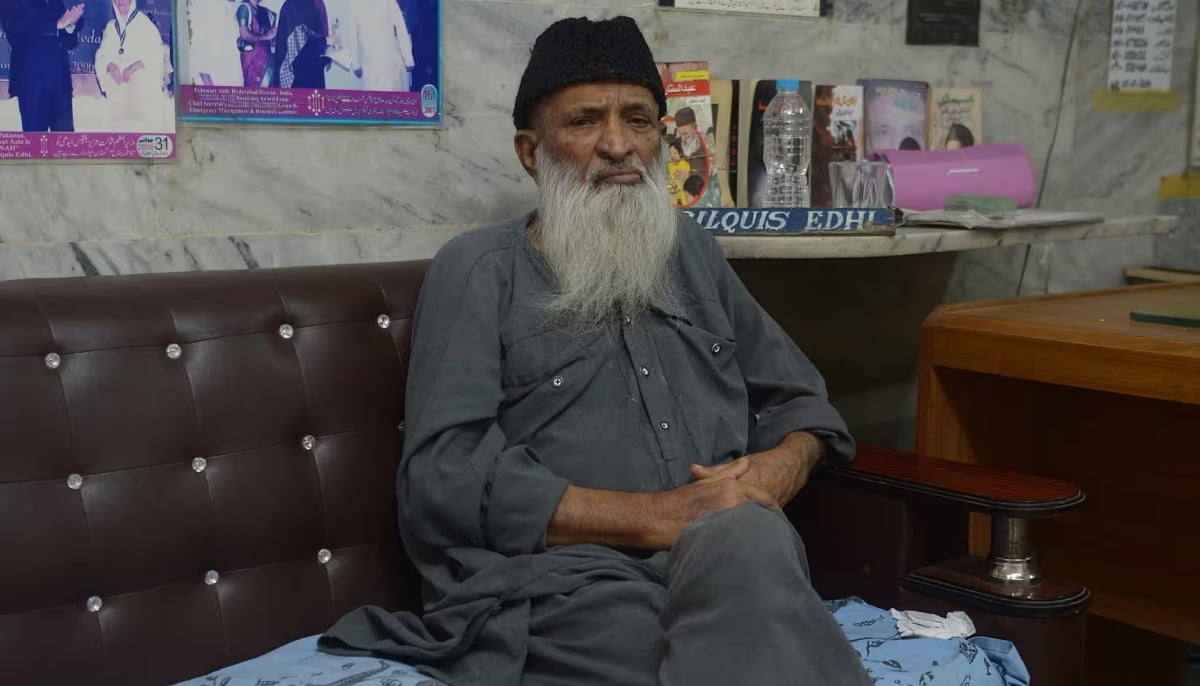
<box><xmin>320</xmin><ymin>18</ymin><xmax>870</xmax><ymax>686</ymax></box>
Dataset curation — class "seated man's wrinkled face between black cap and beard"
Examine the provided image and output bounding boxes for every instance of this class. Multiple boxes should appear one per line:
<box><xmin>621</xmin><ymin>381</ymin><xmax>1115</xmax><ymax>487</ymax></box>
<box><xmin>534</xmin><ymin>82</ymin><xmax>661</xmax><ymax>185</ymax></box>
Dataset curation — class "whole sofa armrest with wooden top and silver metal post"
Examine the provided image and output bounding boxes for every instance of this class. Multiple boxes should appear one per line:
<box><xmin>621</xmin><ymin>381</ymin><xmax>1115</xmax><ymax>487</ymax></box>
<box><xmin>787</xmin><ymin>445</ymin><xmax>1091</xmax><ymax>686</ymax></box>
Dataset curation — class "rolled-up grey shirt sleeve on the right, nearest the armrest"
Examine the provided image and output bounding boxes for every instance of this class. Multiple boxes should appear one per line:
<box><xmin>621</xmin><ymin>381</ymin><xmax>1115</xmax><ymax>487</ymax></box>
<box><xmin>710</xmin><ymin>240</ymin><xmax>854</xmax><ymax>464</ymax></box>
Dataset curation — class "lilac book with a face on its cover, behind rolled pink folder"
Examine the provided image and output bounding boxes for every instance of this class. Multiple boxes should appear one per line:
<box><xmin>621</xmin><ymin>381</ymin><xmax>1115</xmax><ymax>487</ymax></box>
<box><xmin>858</xmin><ymin>79</ymin><xmax>929</xmax><ymax>155</ymax></box>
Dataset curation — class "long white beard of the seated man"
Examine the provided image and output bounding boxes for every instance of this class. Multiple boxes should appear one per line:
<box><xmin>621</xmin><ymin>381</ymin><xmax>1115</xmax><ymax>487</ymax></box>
<box><xmin>534</xmin><ymin>145</ymin><xmax>679</xmax><ymax>331</ymax></box>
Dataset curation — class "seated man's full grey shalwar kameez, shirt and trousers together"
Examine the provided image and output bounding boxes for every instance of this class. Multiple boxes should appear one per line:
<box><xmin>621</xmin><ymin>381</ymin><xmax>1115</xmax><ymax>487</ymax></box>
<box><xmin>320</xmin><ymin>216</ymin><xmax>870</xmax><ymax>686</ymax></box>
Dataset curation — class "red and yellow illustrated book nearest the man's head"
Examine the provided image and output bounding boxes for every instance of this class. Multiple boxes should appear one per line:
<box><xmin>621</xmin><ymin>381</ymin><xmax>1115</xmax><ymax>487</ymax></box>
<box><xmin>656</xmin><ymin>61</ymin><xmax>721</xmax><ymax>209</ymax></box>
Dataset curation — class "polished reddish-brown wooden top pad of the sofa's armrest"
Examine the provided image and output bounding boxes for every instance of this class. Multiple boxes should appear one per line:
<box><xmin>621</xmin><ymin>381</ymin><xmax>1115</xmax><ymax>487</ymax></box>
<box><xmin>829</xmin><ymin>445</ymin><xmax>1086</xmax><ymax>519</ymax></box>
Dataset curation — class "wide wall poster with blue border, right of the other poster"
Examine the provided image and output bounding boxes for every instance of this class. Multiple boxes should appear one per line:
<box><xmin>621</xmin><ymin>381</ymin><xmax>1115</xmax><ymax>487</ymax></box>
<box><xmin>179</xmin><ymin>0</ymin><xmax>442</xmax><ymax>126</ymax></box>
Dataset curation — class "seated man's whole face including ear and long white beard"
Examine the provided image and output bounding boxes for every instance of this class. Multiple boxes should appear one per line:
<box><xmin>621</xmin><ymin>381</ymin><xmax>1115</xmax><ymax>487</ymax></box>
<box><xmin>514</xmin><ymin>82</ymin><xmax>678</xmax><ymax>331</ymax></box>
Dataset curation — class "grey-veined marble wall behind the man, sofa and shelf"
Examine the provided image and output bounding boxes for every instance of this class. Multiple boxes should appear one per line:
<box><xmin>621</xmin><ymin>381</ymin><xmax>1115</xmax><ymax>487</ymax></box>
<box><xmin>0</xmin><ymin>0</ymin><xmax>1200</xmax><ymax>444</ymax></box>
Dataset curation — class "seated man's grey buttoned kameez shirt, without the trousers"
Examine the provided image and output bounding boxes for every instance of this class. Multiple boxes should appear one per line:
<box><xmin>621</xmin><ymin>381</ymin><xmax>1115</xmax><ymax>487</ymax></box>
<box><xmin>322</xmin><ymin>215</ymin><xmax>854</xmax><ymax>682</ymax></box>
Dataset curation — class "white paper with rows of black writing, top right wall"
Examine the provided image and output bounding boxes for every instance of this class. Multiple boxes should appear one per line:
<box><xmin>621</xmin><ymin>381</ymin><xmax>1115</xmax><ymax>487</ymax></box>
<box><xmin>1109</xmin><ymin>0</ymin><xmax>1176</xmax><ymax>90</ymax></box>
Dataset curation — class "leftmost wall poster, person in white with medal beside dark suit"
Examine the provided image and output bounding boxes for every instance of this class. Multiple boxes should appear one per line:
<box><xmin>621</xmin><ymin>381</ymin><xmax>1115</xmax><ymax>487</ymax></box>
<box><xmin>0</xmin><ymin>0</ymin><xmax>175</xmax><ymax>160</ymax></box>
